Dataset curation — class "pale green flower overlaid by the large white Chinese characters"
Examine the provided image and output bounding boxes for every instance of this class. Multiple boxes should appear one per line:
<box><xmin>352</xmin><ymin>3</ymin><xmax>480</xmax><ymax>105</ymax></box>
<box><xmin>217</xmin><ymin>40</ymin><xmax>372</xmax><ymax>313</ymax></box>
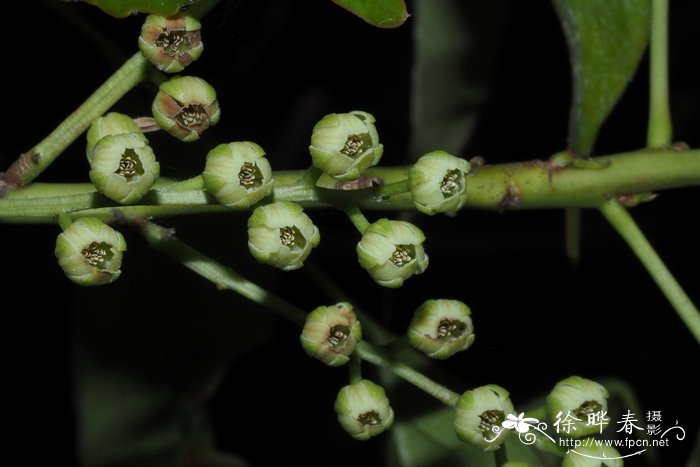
<box><xmin>547</xmin><ymin>376</ymin><xmax>609</xmax><ymax>438</ymax></box>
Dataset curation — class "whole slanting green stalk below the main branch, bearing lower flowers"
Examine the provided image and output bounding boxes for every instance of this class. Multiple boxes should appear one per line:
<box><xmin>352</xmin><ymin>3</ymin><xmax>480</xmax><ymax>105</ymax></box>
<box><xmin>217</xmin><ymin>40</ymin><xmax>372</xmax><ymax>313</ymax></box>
<box><xmin>139</xmin><ymin>219</ymin><xmax>459</xmax><ymax>406</ymax></box>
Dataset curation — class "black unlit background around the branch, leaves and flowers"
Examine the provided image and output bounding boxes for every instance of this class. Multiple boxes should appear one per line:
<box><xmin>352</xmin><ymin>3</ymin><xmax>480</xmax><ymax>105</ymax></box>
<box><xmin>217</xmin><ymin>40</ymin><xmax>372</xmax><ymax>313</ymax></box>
<box><xmin>0</xmin><ymin>0</ymin><xmax>700</xmax><ymax>465</ymax></box>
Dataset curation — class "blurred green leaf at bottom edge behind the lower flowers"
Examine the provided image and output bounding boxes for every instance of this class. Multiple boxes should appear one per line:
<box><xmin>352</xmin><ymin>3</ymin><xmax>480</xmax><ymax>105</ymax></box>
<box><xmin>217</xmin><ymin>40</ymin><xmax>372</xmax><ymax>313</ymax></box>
<box><xmin>389</xmin><ymin>407</ymin><xmax>561</xmax><ymax>467</ymax></box>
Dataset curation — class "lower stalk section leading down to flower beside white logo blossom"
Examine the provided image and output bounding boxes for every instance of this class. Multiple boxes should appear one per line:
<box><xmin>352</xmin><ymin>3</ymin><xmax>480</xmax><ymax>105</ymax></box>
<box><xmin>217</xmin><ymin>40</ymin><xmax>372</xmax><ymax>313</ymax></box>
<box><xmin>355</xmin><ymin>341</ymin><xmax>460</xmax><ymax>407</ymax></box>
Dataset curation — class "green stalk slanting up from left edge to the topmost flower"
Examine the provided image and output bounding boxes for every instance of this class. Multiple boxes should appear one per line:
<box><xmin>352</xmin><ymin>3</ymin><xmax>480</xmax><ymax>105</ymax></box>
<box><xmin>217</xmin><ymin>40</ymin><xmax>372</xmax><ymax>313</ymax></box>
<box><xmin>0</xmin><ymin>52</ymin><xmax>150</xmax><ymax>192</ymax></box>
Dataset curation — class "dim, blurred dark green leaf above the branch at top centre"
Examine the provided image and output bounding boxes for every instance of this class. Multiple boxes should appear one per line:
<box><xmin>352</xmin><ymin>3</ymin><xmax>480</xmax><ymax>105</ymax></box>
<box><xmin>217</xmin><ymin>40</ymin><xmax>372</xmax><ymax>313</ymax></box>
<box><xmin>410</xmin><ymin>0</ymin><xmax>508</xmax><ymax>160</ymax></box>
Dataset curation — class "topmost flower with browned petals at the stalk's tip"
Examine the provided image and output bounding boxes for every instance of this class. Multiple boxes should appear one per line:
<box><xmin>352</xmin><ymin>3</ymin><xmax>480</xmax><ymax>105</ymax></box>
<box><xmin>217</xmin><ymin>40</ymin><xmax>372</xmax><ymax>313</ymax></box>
<box><xmin>139</xmin><ymin>15</ymin><xmax>204</xmax><ymax>73</ymax></box>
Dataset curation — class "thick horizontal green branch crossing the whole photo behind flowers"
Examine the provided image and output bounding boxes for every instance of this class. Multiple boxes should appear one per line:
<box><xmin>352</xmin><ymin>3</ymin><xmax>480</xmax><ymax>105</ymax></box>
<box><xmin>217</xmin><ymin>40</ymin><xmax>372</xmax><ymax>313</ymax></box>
<box><xmin>0</xmin><ymin>149</ymin><xmax>700</xmax><ymax>223</ymax></box>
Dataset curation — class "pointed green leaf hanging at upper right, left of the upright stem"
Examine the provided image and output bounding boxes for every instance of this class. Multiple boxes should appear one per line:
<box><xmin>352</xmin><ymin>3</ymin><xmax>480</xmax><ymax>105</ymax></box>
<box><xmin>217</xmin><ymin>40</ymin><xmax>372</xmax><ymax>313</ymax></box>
<box><xmin>554</xmin><ymin>0</ymin><xmax>651</xmax><ymax>156</ymax></box>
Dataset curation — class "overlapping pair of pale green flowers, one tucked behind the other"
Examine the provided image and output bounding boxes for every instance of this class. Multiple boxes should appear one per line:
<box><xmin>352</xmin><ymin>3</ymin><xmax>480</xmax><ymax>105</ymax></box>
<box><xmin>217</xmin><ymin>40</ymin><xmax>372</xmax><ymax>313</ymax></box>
<box><xmin>87</xmin><ymin>113</ymin><xmax>160</xmax><ymax>204</ymax></box>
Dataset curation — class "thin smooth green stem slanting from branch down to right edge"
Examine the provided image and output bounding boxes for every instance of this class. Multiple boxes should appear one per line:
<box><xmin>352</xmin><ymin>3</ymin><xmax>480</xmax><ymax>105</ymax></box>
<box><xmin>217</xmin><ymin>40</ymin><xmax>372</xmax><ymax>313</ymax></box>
<box><xmin>600</xmin><ymin>199</ymin><xmax>700</xmax><ymax>343</ymax></box>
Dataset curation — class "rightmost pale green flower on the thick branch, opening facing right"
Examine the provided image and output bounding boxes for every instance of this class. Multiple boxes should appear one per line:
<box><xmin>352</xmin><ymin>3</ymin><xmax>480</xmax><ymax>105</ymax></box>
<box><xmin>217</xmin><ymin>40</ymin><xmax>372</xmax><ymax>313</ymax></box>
<box><xmin>408</xmin><ymin>151</ymin><xmax>471</xmax><ymax>215</ymax></box>
